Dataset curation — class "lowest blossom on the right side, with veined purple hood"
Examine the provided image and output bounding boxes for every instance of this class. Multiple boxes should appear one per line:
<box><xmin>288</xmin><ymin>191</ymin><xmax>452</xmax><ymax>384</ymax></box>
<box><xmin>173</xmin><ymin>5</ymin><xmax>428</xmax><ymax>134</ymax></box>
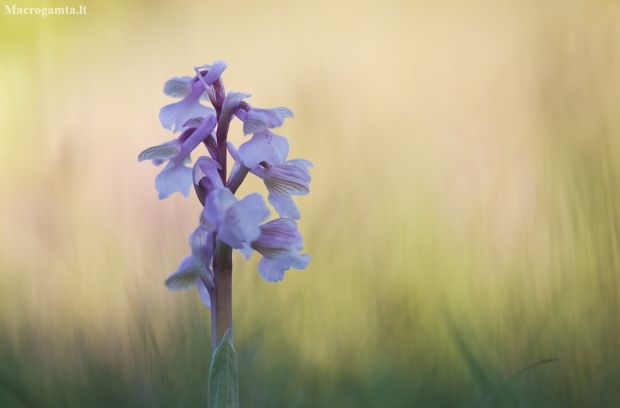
<box><xmin>242</xmin><ymin>218</ymin><xmax>310</xmax><ymax>282</ymax></box>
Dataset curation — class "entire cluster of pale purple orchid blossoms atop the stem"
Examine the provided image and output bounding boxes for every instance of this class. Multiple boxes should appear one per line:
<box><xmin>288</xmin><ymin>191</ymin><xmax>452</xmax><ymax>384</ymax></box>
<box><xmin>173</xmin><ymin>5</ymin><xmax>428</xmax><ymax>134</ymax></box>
<box><xmin>138</xmin><ymin>61</ymin><xmax>312</xmax><ymax>307</ymax></box>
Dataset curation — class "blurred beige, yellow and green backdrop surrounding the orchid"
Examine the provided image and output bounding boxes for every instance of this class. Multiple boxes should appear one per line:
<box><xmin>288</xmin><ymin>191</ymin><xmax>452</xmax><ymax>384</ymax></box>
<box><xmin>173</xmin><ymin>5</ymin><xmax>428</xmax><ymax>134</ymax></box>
<box><xmin>0</xmin><ymin>0</ymin><xmax>620</xmax><ymax>408</ymax></box>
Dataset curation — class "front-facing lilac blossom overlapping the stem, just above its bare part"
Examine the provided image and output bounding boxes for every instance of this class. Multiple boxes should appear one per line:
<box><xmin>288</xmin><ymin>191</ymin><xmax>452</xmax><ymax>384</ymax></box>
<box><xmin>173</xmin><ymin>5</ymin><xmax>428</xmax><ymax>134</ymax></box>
<box><xmin>200</xmin><ymin>188</ymin><xmax>269</xmax><ymax>249</ymax></box>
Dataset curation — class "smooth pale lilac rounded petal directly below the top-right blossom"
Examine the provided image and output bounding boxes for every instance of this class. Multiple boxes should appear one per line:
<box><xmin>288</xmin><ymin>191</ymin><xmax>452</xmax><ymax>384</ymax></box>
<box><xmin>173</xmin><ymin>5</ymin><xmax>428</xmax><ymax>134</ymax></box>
<box><xmin>239</xmin><ymin>130</ymin><xmax>289</xmax><ymax>169</ymax></box>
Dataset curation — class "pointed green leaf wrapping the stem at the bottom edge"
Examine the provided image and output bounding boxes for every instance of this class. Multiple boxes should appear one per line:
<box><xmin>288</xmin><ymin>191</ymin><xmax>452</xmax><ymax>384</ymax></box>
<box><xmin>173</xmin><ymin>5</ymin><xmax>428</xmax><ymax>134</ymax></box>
<box><xmin>209</xmin><ymin>329</ymin><xmax>239</xmax><ymax>408</ymax></box>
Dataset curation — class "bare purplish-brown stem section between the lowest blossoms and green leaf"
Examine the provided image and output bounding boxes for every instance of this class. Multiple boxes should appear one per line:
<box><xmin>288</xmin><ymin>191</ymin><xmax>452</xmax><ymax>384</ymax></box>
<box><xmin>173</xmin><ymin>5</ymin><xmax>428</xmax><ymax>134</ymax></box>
<box><xmin>211</xmin><ymin>240</ymin><xmax>233</xmax><ymax>352</ymax></box>
